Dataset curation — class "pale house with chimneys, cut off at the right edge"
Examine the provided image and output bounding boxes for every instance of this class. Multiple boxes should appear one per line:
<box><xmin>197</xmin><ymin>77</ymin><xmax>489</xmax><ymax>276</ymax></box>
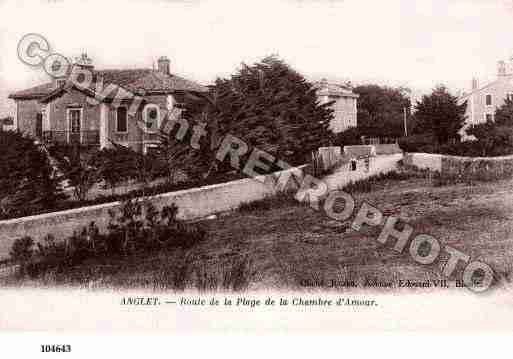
<box><xmin>459</xmin><ymin>58</ymin><xmax>513</xmax><ymax>138</ymax></box>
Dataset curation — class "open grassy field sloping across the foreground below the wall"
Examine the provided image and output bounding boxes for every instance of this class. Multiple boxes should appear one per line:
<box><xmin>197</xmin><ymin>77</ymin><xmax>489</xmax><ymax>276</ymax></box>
<box><xmin>3</xmin><ymin>174</ymin><xmax>513</xmax><ymax>291</ymax></box>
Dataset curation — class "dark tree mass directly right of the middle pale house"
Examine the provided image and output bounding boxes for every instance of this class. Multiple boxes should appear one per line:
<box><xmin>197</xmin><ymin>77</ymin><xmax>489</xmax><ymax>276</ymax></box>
<box><xmin>353</xmin><ymin>84</ymin><xmax>411</xmax><ymax>137</ymax></box>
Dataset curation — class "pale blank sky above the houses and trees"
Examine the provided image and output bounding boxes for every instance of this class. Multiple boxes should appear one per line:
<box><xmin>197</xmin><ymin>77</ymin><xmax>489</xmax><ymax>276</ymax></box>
<box><xmin>0</xmin><ymin>0</ymin><xmax>513</xmax><ymax>97</ymax></box>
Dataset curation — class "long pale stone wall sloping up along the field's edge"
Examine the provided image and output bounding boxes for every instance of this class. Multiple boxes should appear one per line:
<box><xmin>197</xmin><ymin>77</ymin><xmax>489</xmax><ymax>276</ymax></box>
<box><xmin>0</xmin><ymin>154</ymin><xmax>402</xmax><ymax>260</ymax></box>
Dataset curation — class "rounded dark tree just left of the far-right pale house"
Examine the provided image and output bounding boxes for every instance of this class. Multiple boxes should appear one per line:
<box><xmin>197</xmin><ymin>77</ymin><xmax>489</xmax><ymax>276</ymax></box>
<box><xmin>415</xmin><ymin>85</ymin><xmax>467</xmax><ymax>144</ymax></box>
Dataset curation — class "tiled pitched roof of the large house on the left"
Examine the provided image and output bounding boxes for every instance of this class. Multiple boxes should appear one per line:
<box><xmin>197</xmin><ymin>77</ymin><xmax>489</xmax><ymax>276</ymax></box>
<box><xmin>9</xmin><ymin>69</ymin><xmax>207</xmax><ymax>100</ymax></box>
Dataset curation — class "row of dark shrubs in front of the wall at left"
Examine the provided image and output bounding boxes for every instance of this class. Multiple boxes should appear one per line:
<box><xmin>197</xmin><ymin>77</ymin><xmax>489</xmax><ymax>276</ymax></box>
<box><xmin>11</xmin><ymin>200</ymin><xmax>208</xmax><ymax>276</ymax></box>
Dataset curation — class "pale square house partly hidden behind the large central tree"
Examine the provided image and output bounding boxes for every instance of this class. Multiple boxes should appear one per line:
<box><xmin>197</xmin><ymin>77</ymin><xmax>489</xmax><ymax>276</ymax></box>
<box><xmin>314</xmin><ymin>79</ymin><xmax>359</xmax><ymax>133</ymax></box>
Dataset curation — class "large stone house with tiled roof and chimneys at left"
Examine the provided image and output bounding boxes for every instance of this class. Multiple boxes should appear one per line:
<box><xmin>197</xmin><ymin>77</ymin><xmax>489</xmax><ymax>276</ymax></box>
<box><xmin>9</xmin><ymin>55</ymin><xmax>207</xmax><ymax>152</ymax></box>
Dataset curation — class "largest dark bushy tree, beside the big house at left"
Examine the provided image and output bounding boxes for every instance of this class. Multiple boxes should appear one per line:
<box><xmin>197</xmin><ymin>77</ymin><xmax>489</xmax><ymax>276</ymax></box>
<box><xmin>180</xmin><ymin>56</ymin><xmax>333</xmax><ymax>179</ymax></box>
